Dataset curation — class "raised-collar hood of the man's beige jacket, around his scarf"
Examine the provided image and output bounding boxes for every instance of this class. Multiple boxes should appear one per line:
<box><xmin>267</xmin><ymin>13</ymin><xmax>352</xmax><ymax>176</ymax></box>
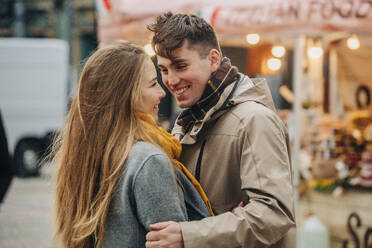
<box><xmin>172</xmin><ymin>73</ymin><xmax>276</xmax><ymax>144</ymax></box>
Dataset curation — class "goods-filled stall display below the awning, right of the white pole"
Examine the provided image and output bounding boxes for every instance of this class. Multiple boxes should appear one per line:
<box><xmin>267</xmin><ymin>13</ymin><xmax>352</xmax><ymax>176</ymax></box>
<box><xmin>296</xmin><ymin>34</ymin><xmax>372</xmax><ymax>247</ymax></box>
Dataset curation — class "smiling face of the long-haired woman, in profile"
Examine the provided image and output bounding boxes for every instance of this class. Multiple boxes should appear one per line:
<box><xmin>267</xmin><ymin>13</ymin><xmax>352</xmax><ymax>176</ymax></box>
<box><xmin>137</xmin><ymin>58</ymin><xmax>165</xmax><ymax>121</ymax></box>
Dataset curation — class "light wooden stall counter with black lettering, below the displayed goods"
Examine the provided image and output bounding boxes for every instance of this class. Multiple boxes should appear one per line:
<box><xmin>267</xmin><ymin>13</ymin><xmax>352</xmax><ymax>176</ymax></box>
<box><xmin>298</xmin><ymin>189</ymin><xmax>372</xmax><ymax>248</ymax></box>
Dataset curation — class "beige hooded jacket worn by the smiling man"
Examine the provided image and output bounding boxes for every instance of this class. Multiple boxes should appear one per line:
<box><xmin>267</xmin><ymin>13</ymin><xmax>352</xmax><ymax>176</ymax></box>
<box><xmin>172</xmin><ymin>74</ymin><xmax>296</xmax><ymax>248</ymax></box>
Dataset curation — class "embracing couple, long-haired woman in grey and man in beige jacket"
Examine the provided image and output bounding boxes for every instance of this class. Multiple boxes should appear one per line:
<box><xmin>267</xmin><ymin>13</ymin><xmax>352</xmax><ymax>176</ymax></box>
<box><xmin>55</xmin><ymin>13</ymin><xmax>295</xmax><ymax>248</ymax></box>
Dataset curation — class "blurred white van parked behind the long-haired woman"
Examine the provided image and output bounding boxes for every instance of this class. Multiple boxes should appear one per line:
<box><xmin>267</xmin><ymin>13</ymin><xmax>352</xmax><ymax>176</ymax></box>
<box><xmin>0</xmin><ymin>38</ymin><xmax>69</xmax><ymax>176</ymax></box>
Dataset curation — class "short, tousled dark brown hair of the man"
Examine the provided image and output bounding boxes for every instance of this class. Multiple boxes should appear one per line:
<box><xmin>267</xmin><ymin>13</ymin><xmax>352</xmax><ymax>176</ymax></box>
<box><xmin>147</xmin><ymin>12</ymin><xmax>220</xmax><ymax>58</ymax></box>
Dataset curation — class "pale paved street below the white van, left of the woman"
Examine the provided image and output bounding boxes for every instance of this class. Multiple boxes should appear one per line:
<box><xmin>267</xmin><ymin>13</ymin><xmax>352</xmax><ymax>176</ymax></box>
<box><xmin>0</xmin><ymin>166</ymin><xmax>56</xmax><ymax>248</ymax></box>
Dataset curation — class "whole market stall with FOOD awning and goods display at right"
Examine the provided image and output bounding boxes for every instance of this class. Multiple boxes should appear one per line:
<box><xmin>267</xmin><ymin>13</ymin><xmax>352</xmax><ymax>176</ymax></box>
<box><xmin>96</xmin><ymin>0</ymin><xmax>372</xmax><ymax>247</ymax></box>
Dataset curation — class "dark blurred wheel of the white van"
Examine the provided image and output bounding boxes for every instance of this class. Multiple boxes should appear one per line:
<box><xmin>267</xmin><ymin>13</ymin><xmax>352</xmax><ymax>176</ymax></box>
<box><xmin>14</xmin><ymin>138</ymin><xmax>42</xmax><ymax>177</ymax></box>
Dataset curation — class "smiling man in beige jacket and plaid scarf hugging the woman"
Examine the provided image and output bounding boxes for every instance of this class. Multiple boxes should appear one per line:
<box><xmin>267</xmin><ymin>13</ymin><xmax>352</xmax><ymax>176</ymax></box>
<box><xmin>146</xmin><ymin>13</ymin><xmax>296</xmax><ymax>248</ymax></box>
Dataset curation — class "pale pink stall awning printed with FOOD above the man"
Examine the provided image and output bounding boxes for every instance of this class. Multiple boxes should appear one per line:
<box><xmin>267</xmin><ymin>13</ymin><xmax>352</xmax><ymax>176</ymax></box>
<box><xmin>96</xmin><ymin>0</ymin><xmax>372</xmax><ymax>41</ymax></box>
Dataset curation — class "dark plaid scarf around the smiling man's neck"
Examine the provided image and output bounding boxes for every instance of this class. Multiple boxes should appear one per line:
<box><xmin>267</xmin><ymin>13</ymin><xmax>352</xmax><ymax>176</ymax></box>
<box><xmin>177</xmin><ymin>57</ymin><xmax>238</xmax><ymax>132</ymax></box>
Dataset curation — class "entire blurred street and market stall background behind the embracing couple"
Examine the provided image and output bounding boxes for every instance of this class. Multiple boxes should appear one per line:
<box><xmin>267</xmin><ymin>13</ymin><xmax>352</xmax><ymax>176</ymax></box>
<box><xmin>0</xmin><ymin>0</ymin><xmax>372</xmax><ymax>248</ymax></box>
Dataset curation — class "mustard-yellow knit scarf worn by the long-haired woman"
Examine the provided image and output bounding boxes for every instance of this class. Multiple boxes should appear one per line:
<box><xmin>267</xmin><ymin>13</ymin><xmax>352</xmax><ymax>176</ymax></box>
<box><xmin>138</xmin><ymin>114</ymin><xmax>214</xmax><ymax>216</ymax></box>
